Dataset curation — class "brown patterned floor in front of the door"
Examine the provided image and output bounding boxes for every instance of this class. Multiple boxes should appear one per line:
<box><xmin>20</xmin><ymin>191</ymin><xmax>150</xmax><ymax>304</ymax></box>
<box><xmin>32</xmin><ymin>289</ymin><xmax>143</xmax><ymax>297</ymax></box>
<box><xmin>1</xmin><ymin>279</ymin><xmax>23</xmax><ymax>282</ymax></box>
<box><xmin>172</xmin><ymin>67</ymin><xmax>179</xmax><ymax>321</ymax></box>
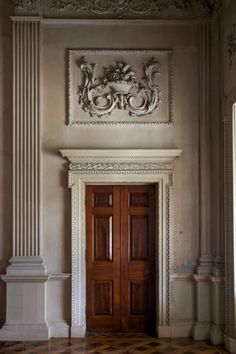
<box><xmin>0</xmin><ymin>334</ymin><xmax>230</xmax><ymax>354</ymax></box>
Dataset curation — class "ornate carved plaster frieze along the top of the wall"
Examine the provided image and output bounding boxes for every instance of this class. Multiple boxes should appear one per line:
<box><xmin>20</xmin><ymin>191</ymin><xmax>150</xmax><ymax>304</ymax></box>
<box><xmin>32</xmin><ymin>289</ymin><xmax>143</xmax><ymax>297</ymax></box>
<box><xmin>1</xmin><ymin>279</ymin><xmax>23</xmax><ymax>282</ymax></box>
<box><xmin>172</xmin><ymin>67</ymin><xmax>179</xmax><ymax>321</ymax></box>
<box><xmin>12</xmin><ymin>0</ymin><xmax>222</xmax><ymax>19</ymax></box>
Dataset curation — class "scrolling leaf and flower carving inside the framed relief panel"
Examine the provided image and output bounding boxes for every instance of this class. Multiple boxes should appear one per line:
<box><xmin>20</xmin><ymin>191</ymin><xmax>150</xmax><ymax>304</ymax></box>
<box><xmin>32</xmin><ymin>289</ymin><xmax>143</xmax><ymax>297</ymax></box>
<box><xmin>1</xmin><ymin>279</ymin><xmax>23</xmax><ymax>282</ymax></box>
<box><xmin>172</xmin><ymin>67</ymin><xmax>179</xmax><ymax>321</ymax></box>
<box><xmin>78</xmin><ymin>57</ymin><xmax>161</xmax><ymax>117</ymax></box>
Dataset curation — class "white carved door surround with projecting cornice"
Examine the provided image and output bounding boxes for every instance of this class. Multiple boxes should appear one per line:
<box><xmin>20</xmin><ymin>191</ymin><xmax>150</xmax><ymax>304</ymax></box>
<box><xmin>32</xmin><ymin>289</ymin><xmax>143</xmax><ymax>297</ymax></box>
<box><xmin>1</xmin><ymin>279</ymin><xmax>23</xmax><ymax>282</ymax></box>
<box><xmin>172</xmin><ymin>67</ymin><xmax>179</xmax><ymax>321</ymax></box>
<box><xmin>60</xmin><ymin>149</ymin><xmax>182</xmax><ymax>337</ymax></box>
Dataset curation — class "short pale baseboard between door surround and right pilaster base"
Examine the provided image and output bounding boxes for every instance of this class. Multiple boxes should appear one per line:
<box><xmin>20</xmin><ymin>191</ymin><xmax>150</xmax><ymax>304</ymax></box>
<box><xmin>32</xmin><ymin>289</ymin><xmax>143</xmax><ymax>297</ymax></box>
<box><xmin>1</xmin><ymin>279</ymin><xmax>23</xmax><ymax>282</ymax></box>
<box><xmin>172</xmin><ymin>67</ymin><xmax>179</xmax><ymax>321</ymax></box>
<box><xmin>157</xmin><ymin>321</ymin><xmax>194</xmax><ymax>338</ymax></box>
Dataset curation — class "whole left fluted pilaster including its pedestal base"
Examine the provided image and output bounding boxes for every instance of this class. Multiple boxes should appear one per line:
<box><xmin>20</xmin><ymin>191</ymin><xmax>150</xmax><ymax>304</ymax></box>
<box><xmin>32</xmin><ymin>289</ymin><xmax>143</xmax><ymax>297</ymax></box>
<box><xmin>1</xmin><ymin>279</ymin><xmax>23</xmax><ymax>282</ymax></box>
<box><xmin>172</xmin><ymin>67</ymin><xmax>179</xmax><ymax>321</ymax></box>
<box><xmin>0</xmin><ymin>17</ymin><xmax>49</xmax><ymax>340</ymax></box>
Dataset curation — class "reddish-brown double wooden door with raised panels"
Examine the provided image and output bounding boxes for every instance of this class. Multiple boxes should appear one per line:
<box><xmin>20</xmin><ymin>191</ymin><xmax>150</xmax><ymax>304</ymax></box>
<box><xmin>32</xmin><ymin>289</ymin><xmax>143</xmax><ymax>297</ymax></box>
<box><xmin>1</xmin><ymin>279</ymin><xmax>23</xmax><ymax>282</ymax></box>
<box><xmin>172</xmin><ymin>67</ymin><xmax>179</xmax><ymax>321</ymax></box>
<box><xmin>86</xmin><ymin>185</ymin><xmax>155</xmax><ymax>332</ymax></box>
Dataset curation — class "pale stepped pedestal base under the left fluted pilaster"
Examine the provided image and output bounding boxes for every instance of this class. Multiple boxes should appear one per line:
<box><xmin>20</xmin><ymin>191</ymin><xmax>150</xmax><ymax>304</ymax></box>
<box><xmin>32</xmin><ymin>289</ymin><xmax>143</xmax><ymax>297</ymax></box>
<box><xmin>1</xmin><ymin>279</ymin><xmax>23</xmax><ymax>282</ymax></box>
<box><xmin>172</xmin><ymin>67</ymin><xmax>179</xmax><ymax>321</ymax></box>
<box><xmin>0</xmin><ymin>257</ymin><xmax>49</xmax><ymax>341</ymax></box>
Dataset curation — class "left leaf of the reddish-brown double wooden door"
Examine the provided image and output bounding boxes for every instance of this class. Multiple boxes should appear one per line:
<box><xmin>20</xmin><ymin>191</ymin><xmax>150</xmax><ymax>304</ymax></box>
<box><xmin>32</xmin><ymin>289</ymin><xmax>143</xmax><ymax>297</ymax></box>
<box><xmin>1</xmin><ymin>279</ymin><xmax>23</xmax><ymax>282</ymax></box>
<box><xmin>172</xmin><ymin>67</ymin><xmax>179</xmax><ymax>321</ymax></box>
<box><xmin>86</xmin><ymin>186</ymin><xmax>120</xmax><ymax>332</ymax></box>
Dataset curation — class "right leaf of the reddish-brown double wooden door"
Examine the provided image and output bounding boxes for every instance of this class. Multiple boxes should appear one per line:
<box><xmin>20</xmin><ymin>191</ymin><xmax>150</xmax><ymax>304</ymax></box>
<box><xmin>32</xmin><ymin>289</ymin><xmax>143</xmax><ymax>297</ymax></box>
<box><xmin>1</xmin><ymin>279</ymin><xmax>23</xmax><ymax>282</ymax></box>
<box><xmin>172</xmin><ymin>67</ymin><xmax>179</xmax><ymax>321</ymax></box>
<box><xmin>121</xmin><ymin>186</ymin><xmax>155</xmax><ymax>332</ymax></box>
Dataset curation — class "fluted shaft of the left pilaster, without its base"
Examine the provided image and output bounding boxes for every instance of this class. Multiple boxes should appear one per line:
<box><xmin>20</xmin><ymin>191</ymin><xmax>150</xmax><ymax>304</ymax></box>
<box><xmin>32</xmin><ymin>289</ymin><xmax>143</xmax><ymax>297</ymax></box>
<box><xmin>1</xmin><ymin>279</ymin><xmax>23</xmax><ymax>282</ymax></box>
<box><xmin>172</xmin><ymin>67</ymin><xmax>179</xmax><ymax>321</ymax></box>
<box><xmin>12</xmin><ymin>19</ymin><xmax>40</xmax><ymax>256</ymax></box>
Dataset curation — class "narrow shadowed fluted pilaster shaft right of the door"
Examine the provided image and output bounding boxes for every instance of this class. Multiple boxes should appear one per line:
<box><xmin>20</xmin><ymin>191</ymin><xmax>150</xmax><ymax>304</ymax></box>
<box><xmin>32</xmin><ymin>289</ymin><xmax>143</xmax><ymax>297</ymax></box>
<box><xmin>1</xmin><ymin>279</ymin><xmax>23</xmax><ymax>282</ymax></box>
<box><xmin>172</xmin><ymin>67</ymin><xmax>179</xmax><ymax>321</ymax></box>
<box><xmin>198</xmin><ymin>22</ymin><xmax>213</xmax><ymax>274</ymax></box>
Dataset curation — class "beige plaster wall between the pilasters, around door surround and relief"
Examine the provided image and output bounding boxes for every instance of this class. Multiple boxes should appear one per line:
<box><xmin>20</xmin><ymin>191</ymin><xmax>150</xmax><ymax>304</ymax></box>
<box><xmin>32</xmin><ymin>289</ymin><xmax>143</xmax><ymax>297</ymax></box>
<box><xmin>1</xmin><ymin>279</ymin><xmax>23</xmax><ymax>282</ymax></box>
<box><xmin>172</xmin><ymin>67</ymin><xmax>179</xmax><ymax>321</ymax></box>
<box><xmin>41</xmin><ymin>20</ymin><xmax>199</xmax><ymax>322</ymax></box>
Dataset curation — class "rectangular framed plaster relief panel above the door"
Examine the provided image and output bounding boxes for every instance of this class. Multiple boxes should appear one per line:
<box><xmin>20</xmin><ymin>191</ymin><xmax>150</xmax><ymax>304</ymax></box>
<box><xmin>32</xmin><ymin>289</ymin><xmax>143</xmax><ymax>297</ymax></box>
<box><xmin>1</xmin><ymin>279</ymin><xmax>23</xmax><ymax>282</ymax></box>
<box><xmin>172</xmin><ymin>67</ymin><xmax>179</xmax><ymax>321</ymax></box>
<box><xmin>68</xmin><ymin>49</ymin><xmax>173</xmax><ymax>125</ymax></box>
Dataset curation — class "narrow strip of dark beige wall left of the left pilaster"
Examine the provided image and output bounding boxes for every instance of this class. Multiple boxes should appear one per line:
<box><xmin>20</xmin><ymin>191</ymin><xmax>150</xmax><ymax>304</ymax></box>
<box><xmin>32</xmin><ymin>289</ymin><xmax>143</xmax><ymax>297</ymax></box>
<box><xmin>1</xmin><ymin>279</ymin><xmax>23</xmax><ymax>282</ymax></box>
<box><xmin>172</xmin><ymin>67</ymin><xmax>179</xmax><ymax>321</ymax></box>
<box><xmin>0</xmin><ymin>0</ymin><xmax>12</xmax><ymax>322</ymax></box>
